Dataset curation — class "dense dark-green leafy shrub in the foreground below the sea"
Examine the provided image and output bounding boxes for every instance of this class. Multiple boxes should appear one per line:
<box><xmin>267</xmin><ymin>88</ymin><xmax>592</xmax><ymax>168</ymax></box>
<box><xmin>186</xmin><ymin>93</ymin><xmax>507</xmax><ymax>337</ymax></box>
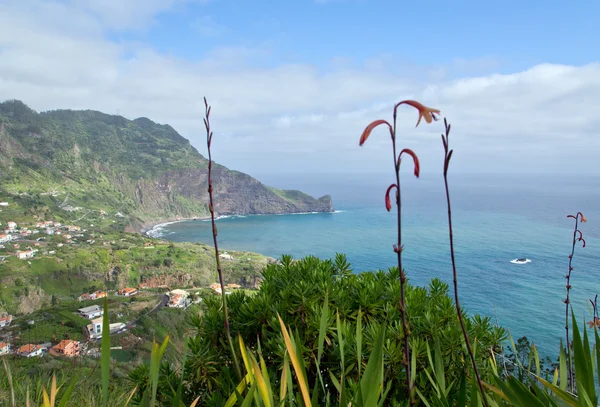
<box><xmin>184</xmin><ymin>256</ymin><xmax>504</xmax><ymax>399</ymax></box>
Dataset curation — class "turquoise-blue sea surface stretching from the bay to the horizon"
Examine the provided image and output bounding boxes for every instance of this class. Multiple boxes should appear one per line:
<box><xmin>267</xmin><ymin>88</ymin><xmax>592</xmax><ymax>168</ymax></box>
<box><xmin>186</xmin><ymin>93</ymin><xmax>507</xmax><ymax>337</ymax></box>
<box><xmin>153</xmin><ymin>174</ymin><xmax>600</xmax><ymax>355</ymax></box>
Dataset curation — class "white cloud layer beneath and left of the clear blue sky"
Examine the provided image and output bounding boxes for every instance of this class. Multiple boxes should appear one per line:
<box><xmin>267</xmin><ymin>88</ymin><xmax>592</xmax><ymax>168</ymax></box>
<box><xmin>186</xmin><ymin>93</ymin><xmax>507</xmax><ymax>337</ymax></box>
<box><xmin>0</xmin><ymin>0</ymin><xmax>600</xmax><ymax>178</ymax></box>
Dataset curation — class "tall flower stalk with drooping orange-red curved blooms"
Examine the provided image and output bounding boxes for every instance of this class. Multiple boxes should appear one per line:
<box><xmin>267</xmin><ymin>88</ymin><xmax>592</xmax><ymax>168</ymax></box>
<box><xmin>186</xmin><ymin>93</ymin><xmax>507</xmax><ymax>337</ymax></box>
<box><xmin>359</xmin><ymin>100</ymin><xmax>440</xmax><ymax>404</ymax></box>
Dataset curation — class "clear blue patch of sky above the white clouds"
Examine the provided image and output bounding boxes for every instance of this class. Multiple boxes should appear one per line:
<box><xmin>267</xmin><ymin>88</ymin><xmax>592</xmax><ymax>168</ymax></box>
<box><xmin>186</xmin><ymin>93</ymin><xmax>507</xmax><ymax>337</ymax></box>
<box><xmin>119</xmin><ymin>0</ymin><xmax>600</xmax><ymax>72</ymax></box>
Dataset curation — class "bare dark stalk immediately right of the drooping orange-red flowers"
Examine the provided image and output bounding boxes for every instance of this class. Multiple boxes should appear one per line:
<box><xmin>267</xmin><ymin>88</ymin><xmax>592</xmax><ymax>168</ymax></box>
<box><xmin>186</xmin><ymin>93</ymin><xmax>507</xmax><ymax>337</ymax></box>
<box><xmin>442</xmin><ymin>118</ymin><xmax>487</xmax><ymax>406</ymax></box>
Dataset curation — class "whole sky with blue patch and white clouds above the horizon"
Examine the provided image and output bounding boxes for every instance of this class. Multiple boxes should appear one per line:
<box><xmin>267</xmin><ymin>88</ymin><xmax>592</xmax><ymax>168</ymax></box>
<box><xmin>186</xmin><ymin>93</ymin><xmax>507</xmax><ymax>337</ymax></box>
<box><xmin>0</xmin><ymin>0</ymin><xmax>600</xmax><ymax>175</ymax></box>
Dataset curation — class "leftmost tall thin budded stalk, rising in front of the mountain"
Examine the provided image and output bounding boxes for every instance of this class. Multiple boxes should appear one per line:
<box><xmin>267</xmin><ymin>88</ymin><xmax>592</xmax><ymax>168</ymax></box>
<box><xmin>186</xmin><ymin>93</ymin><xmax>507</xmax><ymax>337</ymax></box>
<box><xmin>204</xmin><ymin>98</ymin><xmax>242</xmax><ymax>379</ymax></box>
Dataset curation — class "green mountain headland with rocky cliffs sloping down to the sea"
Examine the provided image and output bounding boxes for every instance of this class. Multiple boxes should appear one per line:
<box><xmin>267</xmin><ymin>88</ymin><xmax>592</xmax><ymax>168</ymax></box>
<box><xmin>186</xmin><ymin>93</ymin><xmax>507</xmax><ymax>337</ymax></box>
<box><xmin>0</xmin><ymin>100</ymin><xmax>333</xmax><ymax>230</ymax></box>
